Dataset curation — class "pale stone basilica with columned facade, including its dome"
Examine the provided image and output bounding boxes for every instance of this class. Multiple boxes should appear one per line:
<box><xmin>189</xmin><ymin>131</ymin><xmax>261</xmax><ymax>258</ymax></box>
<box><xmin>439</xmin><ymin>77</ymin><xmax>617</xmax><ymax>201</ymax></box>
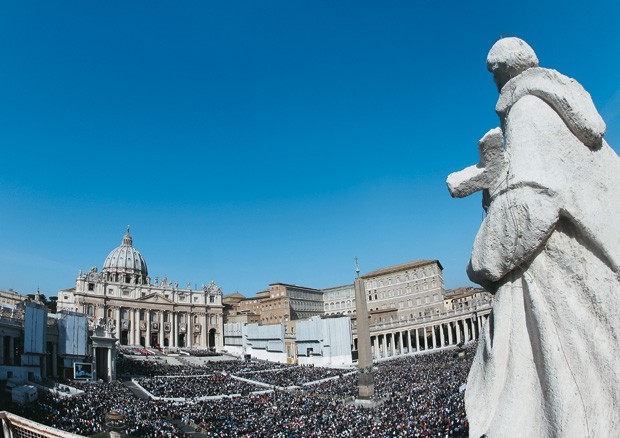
<box><xmin>58</xmin><ymin>228</ymin><xmax>223</xmax><ymax>350</ymax></box>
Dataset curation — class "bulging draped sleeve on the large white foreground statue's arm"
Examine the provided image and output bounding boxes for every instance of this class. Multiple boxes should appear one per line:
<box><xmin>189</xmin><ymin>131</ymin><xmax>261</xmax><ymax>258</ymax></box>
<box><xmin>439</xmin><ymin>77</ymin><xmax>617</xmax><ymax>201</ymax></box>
<box><xmin>467</xmin><ymin>185</ymin><xmax>559</xmax><ymax>289</ymax></box>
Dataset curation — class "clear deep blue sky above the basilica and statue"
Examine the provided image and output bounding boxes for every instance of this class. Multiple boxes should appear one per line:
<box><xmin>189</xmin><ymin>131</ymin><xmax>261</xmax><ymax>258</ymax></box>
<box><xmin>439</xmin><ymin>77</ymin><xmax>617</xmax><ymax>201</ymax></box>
<box><xmin>0</xmin><ymin>0</ymin><xmax>620</xmax><ymax>296</ymax></box>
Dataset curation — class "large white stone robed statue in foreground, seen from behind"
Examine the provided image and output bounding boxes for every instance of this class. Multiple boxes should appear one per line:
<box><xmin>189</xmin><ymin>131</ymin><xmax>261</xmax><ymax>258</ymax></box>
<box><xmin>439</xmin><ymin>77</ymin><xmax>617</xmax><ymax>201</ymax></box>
<box><xmin>447</xmin><ymin>38</ymin><xmax>620</xmax><ymax>437</ymax></box>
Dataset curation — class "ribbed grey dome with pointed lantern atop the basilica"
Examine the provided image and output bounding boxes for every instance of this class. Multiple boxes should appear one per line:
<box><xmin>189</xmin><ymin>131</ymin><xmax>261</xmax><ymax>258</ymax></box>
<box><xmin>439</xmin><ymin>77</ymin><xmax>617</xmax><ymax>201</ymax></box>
<box><xmin>103</xmin><ymin>227</ymin><xmax>149</xmax><ymax>284</ymax></box>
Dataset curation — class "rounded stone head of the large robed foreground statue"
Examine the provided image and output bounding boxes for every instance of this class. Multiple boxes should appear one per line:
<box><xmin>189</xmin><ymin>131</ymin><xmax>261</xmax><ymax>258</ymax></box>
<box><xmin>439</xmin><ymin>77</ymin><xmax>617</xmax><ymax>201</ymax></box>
<box><xmin>487</xmin><ymin>37</ymin><xmax>538</xmax><ymax>91</ymax></box>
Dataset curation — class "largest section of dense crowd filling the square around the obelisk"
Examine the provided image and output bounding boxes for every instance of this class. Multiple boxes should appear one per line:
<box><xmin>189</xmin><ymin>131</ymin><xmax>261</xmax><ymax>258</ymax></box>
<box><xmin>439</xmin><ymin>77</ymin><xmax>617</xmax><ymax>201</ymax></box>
<box><xmin>10</xmin><ymin>347</ymin><xmax>472</xmax><ymax>437</ymax></box>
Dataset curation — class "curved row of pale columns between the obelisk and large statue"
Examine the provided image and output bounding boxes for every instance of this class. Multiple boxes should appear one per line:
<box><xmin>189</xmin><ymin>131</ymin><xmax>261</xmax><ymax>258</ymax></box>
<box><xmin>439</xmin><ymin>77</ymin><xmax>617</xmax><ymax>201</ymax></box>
<box><xmin>370</xmin><ymin>313</ymin><xmax>488</xmax><ymax>359</ymax></box>
